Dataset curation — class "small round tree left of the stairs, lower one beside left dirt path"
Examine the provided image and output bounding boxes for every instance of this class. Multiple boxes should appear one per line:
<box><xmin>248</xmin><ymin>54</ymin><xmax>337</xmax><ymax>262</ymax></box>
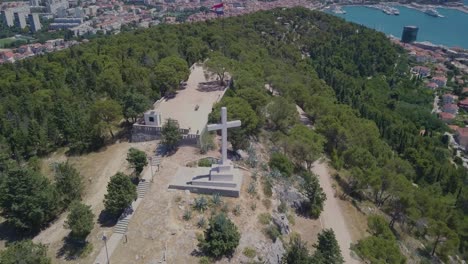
<box><xmin>65</xmin><ymin>201</ymin><xmax>94</xmax><ymax>241</ymax></box>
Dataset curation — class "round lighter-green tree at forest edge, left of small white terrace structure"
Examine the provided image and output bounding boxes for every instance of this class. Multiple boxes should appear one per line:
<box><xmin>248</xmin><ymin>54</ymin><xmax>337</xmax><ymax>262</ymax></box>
<box><xmin>91</xmin><ymin>99</ymin><xmax>122</xmax><ymax>138</ymax></box>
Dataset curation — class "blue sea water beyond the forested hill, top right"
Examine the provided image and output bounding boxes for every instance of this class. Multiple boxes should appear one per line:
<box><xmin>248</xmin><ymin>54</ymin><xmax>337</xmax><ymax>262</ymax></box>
<box><xmin>334</xmin><ymin>5</ymin><xmax>468</xmax><ymax>49</ymax></box>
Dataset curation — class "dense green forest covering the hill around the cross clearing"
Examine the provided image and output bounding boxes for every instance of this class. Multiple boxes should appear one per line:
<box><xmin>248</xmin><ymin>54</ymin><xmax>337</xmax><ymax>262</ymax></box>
<box><xmin>0</xmin><ymin>8</ymin><xmax>468</xmax><ymax>263</ymax></box>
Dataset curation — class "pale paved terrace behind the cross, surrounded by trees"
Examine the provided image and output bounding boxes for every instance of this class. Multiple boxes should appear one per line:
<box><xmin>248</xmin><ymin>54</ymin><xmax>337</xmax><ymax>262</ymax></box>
<box><xmin>154</xmin><ymin>64</ymin><xmax>226</xmax><ymax>134</ymax></box>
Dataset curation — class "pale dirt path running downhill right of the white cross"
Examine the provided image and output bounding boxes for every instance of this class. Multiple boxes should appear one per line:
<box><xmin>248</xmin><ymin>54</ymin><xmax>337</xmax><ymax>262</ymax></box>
<box><xmin>312</xmin><ymin>160</ymin><xmax>360</xmax><ymax>264</ymax></box>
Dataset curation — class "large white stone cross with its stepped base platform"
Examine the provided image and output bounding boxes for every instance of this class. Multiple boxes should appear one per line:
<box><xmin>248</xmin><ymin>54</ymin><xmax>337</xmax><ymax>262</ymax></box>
<box><xmin>169</xmin><ymin>107</ymin><xmax>242</xmax><ymax>197</ymax></box>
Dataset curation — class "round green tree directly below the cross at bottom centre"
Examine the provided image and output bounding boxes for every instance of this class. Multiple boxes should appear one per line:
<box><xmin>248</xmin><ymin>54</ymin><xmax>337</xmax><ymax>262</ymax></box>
<box><xmin>198</xmin><ymin>214</ymin><xmax>240</xmax><ymax>258</ymax></box>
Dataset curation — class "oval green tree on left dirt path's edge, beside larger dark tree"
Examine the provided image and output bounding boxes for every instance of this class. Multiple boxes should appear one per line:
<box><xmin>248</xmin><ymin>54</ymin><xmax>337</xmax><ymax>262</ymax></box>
<box><xmin>55</xmin><ymin>162</ymin><xmax>83</xmax><ymax>207</ymax></box>
